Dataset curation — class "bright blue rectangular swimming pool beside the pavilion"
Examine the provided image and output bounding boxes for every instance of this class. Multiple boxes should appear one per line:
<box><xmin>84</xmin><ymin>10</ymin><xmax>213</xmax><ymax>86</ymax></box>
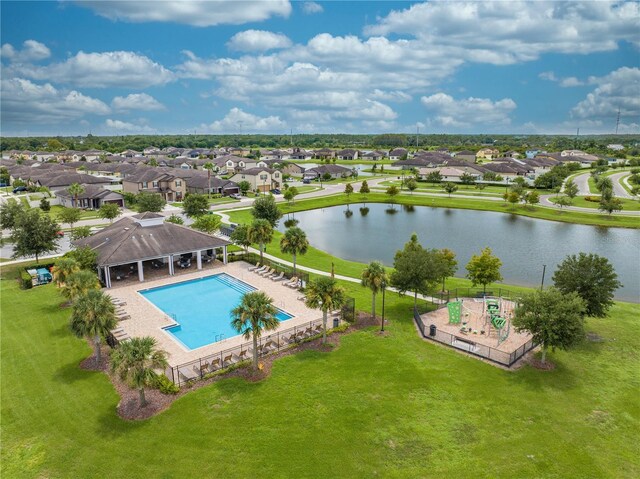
<box><xmin>140</xmin><ymin>273</ymin><xmax>293</xmax><ymax>349</ymax></box>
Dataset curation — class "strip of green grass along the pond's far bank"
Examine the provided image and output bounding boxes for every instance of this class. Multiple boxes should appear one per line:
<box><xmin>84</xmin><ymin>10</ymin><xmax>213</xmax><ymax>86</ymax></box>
<box><xmin>229</xmin><ymin>187</ymin><xmax>640</xmax><ymax>228</ymax></box>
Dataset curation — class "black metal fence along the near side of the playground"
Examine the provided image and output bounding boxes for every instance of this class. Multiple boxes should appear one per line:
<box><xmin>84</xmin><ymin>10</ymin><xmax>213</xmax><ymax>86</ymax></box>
<box><xmin>413</xmin><ymin>308</ymin><xmax>536</xmax><ymax>367</ymax></box>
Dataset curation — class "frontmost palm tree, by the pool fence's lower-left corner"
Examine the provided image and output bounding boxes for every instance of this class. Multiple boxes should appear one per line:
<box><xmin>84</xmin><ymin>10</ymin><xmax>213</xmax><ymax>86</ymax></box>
<box><xmin>111</xmin><ymin>336</ymin><xmax>169</xmax><ymax>407</ymax></box>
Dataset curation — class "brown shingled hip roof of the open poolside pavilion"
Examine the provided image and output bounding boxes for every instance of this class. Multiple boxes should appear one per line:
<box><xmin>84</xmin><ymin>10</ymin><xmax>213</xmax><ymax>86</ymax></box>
<box><xmin>73</xmin><ymin>217</ymin><xmax>230</xmax><ymax>266</ymax></box>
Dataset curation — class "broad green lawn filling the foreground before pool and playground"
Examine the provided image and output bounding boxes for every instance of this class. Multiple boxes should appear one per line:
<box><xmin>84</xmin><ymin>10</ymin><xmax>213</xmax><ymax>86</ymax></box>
<box><xmin>0</xmin><ymin>262</ymin><xmax>640</xmax><ymax>478</ymax></box>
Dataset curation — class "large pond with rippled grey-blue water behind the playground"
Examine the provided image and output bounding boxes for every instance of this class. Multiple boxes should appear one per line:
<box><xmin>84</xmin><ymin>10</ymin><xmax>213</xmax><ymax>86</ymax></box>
<box><xmin>278</xmin><ymin>203</ymin><xmax>640</xmax><ymax>302</ymax></box>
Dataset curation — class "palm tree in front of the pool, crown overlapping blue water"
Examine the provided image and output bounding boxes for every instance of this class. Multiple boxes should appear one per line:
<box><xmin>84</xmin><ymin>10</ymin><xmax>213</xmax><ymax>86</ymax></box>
<box><xmin>231</xmin><ymin>291</ymin><xmax>280</xmax><ymax>369</ymax></box>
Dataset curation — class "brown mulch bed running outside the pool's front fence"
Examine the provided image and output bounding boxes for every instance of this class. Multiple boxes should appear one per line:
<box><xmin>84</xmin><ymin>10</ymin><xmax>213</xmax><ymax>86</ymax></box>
<box><xmin>80</xmin><ymin>312</ymin><xmax>386</xmax><ymax>420</ymax></box>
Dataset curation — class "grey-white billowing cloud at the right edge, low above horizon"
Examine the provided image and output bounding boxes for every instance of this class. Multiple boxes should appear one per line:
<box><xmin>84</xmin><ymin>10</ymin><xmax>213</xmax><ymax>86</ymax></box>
<box><xmin>571</xmin><ymin>67</ymin><xmax>640</xmax><ymax>121</ymax></box>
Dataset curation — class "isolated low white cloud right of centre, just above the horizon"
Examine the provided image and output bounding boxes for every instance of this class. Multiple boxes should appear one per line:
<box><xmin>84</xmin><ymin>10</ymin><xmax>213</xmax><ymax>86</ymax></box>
<box><xmin>420</xmin><ymin>93</ymin><xmax>516</xmax><ymax>128</ymax></box>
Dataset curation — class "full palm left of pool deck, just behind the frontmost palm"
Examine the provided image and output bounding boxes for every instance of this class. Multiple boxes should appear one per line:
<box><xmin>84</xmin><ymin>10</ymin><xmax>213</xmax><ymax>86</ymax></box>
<box><xmin>71</xmin><ymin>289</ymin><xmax>117</xmax><ymax>364</ymax></box>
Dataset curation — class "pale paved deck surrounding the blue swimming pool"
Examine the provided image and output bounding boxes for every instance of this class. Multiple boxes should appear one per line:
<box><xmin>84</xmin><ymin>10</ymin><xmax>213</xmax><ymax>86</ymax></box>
<box><xmin>105</xmin><ymin>261</ymin><xmax>322</xmax><ymax>366</ymax></box>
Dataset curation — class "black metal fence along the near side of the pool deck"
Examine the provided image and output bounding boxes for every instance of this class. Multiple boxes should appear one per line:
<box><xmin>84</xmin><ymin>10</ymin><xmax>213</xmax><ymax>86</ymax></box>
<box><xmin>165</xmin><ymin>298</ymin><xmax>356</xmax><ymax>386</ymax></box>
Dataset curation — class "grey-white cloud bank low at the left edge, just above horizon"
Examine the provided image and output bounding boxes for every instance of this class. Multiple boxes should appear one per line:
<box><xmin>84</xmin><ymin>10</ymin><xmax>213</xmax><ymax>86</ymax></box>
<box><xmin>2</xmin><ymin>78</ymin><xmax>111</xmax><ymax>124</ymax></box>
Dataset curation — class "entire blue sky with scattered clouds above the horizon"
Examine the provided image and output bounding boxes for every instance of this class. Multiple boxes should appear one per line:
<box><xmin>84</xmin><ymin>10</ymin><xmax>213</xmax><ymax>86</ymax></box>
<box><xmin>0</xmin><ymin>0</ymin><xmax>640</xmax><ymax>136</ymax></box>
